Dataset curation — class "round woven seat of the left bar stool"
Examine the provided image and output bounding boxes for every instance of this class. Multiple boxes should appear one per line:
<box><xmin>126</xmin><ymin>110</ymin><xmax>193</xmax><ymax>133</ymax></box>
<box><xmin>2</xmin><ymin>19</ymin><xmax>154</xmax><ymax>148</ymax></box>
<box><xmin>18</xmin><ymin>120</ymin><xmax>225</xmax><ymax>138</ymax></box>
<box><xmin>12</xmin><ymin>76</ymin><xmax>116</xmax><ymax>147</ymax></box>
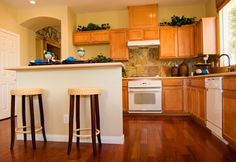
<box><xmin>10</xmin><ymin>88</ymin><xmax>43</xmax><ymax>96</ymax></box>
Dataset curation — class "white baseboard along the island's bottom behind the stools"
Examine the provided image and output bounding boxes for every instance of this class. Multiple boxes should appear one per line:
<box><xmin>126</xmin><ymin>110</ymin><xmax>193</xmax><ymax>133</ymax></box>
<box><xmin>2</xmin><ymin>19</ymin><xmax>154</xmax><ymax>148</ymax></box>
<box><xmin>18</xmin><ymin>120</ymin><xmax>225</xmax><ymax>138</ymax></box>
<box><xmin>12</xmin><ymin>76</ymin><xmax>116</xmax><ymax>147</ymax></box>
<box><xmin>16</xmin><ymin>134</ymin><xmax>124</xmax><ymax>144</ymax></box>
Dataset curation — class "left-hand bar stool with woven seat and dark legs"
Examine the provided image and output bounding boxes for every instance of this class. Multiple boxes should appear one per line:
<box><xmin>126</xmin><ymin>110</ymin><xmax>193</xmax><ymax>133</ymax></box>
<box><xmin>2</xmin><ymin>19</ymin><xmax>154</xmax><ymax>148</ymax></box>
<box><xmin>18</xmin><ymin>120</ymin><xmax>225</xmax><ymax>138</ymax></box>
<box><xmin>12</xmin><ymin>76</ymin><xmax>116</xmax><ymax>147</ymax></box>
<box><xmin>10</xmin><ymin>88</ymin><xmax>47</xmax><ymax>149</ymax></box>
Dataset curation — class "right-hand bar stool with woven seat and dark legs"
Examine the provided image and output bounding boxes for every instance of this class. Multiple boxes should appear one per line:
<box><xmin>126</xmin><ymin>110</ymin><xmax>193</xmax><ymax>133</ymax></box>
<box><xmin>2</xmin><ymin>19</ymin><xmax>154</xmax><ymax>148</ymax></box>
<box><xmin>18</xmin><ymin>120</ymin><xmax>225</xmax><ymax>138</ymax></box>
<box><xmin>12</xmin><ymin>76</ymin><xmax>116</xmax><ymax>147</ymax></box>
<box><xmin>67</xmin><ymin>88</ymin><xmax>102</xmax><ymax>155</ymax></box>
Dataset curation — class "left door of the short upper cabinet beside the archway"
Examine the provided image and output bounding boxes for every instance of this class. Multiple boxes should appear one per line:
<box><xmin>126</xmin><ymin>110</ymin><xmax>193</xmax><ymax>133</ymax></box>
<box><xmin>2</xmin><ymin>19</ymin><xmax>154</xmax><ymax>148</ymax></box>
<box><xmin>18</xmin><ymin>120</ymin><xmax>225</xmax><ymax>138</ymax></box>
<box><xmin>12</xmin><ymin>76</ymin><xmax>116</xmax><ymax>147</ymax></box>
<box><xmin>73</xmin><ymin>32</ymin><xmax>91</xmax><ymax>45</ymax></box>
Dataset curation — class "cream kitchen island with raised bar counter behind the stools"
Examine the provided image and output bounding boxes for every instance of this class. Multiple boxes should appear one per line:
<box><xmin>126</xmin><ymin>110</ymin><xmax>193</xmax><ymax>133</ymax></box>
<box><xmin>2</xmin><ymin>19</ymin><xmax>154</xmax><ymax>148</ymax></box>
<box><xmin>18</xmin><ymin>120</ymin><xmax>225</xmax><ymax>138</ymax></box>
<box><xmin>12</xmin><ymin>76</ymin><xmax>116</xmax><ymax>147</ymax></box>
<box><xmin>7</xmin><ymin>63</ymin><xmax>124</xmax><ymax>144</ymax></box>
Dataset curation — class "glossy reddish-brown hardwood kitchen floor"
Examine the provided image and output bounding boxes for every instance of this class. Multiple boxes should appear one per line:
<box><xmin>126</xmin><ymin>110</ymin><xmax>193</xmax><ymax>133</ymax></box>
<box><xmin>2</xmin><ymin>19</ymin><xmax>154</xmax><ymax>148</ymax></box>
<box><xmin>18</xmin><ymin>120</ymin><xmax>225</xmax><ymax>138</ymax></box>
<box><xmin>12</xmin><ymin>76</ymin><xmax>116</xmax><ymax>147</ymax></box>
<box><xmin>0</xmin><ymin>116</ymin><xmax>236</xmax><ymax>162</ymax></box>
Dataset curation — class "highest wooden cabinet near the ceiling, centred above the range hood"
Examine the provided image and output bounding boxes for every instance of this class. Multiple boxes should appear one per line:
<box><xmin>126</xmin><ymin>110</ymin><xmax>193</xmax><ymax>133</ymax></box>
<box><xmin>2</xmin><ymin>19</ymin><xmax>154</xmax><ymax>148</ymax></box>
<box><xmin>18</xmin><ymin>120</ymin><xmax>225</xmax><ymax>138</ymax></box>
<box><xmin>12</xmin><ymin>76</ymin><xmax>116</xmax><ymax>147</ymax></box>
<box><xmin>128</xmin><ymin>4</ymin><xmax>158</xmax><ymax>28</ymax></box>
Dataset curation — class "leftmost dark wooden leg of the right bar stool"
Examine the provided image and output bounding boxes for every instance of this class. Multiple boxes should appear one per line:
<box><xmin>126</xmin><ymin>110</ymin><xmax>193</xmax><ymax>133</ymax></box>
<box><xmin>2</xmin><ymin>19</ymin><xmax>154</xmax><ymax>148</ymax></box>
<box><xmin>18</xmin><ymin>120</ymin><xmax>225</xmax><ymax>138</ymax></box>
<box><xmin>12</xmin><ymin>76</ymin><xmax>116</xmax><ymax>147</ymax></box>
<box><xmin>67</xmin><ymin>95</ymin><xmax>74</xmax><ymax>155</ymax></box>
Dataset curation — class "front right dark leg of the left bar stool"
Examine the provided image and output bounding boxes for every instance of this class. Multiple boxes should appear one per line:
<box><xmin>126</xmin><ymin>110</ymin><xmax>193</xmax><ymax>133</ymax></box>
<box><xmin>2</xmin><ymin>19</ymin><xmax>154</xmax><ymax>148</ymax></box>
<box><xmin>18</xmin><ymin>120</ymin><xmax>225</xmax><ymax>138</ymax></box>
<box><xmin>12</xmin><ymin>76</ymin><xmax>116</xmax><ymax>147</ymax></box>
<box><xmin>29</xmin><ymin>95</ymin><xmax>36</xmax><ymax>150</ymax></box>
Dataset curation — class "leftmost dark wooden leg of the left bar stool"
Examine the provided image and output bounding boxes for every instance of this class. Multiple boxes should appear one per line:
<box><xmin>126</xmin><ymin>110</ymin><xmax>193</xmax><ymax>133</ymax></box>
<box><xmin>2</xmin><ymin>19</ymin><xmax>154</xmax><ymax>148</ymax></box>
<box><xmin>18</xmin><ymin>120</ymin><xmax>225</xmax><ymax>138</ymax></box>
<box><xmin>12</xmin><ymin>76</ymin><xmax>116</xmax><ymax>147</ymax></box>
<box><xmin>10</xmin><ymin>95</ymin><xmax>15</xmax><ymax>150</ymax></box>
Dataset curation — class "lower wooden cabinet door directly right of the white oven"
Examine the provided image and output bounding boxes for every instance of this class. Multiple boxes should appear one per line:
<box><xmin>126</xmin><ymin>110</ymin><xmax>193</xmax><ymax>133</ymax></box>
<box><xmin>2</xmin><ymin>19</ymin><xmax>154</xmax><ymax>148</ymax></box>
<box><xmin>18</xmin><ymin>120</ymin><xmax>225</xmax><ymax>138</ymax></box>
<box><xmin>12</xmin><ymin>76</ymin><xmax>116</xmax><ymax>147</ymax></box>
<box><xmin>162</xmin><ymin>86</ymin><xmax>183</xmax><ymax>112</ymax></box>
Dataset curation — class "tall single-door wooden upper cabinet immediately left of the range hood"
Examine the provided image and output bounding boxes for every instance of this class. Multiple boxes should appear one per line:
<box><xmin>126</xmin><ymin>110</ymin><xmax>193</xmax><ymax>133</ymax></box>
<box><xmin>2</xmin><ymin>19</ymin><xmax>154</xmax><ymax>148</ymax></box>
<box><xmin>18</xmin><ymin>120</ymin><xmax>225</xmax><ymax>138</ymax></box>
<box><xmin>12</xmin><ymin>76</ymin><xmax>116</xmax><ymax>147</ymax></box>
<box><xmin>110</xmin><ymin>29</ymin><xmax>129</xmax><ymax>60</ymax></box>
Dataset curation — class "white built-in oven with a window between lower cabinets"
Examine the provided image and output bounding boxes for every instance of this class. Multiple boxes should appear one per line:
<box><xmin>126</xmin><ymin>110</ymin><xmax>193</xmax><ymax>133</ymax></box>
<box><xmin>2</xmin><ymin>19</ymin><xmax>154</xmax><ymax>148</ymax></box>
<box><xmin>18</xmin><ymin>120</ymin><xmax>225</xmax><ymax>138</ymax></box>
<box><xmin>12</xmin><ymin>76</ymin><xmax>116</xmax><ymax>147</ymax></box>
<box><xmin>128</xmin><ymin>79</ymin><xmax>162</xmax><ymax>113</ymax></box>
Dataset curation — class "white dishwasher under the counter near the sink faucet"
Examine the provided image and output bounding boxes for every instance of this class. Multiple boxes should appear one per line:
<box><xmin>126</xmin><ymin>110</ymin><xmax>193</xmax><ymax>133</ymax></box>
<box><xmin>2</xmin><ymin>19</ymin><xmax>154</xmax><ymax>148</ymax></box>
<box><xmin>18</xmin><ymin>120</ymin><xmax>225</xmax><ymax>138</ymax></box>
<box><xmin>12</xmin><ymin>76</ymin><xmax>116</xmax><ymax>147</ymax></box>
<box><xmin>205</xmin><ymin>77</ymin><xmax>226</xmax><ymax>143</ymax></box>
